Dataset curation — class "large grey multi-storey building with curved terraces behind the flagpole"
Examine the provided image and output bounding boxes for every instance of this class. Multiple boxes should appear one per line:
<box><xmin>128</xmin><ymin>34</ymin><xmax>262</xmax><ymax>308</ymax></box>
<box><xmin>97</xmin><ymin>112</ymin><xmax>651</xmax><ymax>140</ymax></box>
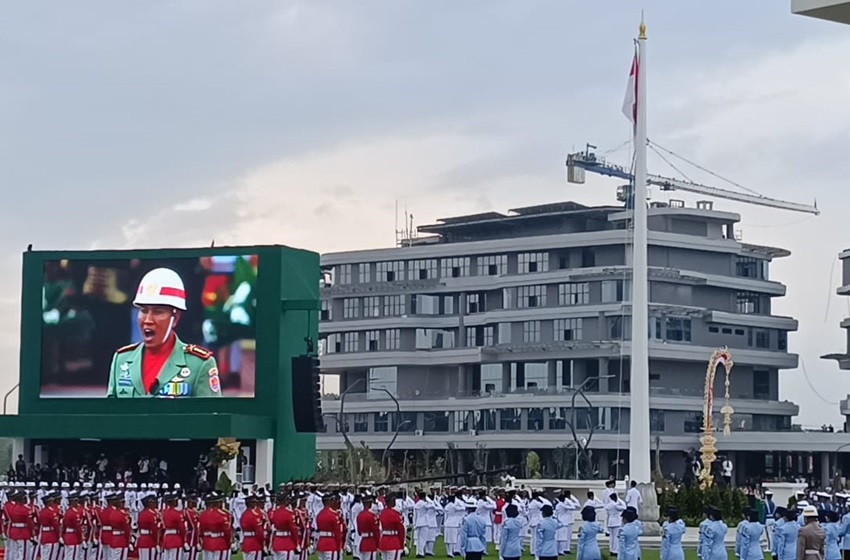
<box><xmin>318</xmin><ymin>201</ymin><xmax>850</xmax><ymax>480</ymax></box>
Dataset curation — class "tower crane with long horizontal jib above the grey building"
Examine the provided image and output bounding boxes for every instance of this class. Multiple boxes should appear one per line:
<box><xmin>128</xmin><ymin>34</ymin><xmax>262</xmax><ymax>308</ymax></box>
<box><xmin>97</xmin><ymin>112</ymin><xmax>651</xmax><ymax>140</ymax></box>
<box><xmin>567</xmin><ymin>144</ymin><xmax>820</xmax><ymax>216</ymax></box>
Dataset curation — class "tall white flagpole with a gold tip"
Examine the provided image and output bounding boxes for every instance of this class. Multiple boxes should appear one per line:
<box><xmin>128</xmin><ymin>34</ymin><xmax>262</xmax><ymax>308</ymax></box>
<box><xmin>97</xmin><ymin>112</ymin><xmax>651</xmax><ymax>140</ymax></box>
<box><xmin>629</xmin><ymin>19</ymin><xmax>652</xmax><ymax>483</ymax></box>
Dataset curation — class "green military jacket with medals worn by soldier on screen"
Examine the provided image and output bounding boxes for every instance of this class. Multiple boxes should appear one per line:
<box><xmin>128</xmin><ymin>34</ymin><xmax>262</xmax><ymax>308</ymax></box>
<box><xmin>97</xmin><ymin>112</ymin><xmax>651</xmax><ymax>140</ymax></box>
<box><xmin>106</xmin><ymin>335</ymin><xmax>221</xmax><ymax>398</ymax></box>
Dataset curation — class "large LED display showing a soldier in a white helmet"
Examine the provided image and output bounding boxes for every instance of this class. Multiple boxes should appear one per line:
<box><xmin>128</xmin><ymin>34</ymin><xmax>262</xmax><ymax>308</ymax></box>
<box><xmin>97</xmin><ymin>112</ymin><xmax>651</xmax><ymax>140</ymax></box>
<box><xmin>41</xmin><ymin>255</ymin><xmax>258</xmax><ymax>399</ymax></box>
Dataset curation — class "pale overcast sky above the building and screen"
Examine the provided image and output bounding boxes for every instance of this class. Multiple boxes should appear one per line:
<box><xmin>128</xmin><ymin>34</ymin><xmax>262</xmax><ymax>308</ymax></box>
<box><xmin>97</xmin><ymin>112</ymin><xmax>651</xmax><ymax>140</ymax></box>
<box><xmin>0</xmin><ymin>0</ymin><xmax>850</xmax><ymax>425</ymax></box>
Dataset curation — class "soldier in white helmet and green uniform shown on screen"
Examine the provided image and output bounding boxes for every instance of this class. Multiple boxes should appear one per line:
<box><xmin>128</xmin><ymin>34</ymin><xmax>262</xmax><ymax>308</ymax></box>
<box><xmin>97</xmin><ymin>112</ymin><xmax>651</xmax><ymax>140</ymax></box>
<box><xmin>107</xmin><ymin>268</ymin><xmax>221</xmax><ymax>398</ymax></box>
